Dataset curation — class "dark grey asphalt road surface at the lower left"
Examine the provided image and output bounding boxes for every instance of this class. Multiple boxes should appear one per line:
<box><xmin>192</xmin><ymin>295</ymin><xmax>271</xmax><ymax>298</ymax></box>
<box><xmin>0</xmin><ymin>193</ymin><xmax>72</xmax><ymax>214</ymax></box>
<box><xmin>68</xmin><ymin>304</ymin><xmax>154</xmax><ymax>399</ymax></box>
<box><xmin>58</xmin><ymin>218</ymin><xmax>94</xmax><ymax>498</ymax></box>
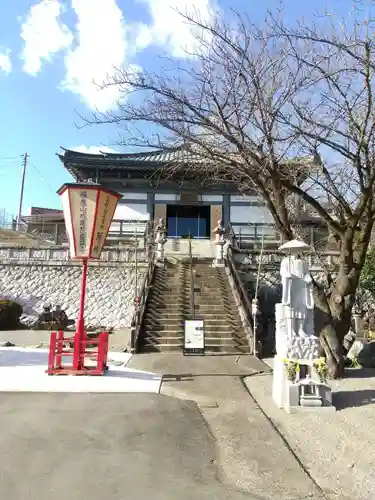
<box><xmin>0</xmin><ymin>393</ymin><xmax>259</xmax><ymax>500</ymax></box>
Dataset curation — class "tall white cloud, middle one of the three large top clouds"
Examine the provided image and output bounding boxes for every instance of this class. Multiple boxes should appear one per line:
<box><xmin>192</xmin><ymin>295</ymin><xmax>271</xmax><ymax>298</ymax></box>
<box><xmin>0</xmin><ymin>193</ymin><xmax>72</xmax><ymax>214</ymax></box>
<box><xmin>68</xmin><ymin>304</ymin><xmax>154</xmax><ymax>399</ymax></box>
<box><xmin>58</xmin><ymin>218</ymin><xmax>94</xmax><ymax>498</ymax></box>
<box><xmin>62</xmin><ymin>0</ymin><xmax>128</xmax><ymax>111</ymax></box>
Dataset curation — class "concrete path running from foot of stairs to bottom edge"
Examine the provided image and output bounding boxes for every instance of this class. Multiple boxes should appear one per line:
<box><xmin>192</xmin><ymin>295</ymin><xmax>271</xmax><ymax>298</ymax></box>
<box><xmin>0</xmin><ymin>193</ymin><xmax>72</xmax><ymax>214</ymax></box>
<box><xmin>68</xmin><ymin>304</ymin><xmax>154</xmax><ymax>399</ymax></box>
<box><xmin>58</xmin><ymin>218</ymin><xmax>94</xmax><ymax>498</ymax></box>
<box><xmin>128</xmin><ymin>354</ymin><xmax>326</xmax><ymax>500</ymax></box>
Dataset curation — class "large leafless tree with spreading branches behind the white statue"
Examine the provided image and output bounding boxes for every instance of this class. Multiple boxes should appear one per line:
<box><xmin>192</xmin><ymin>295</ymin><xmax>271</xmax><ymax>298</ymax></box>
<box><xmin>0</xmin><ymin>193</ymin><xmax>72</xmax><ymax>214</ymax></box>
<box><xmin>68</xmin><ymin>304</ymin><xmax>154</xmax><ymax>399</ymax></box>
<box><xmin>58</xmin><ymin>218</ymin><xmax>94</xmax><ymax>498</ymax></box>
<box><xmin>86</xmin><ymin>5</ymin><xmax>375</xmax><ymax>377</ymax></box>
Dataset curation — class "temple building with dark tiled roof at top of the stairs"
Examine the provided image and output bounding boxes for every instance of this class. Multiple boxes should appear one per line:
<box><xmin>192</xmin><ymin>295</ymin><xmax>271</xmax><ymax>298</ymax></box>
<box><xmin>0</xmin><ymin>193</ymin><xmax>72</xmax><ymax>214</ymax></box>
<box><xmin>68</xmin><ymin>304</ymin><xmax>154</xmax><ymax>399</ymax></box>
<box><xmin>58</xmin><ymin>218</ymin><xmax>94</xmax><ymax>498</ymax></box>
<box><xmin>58</xmin><ymin>148</ymin><xmax>324</xmax><ymax>245</ymax></box>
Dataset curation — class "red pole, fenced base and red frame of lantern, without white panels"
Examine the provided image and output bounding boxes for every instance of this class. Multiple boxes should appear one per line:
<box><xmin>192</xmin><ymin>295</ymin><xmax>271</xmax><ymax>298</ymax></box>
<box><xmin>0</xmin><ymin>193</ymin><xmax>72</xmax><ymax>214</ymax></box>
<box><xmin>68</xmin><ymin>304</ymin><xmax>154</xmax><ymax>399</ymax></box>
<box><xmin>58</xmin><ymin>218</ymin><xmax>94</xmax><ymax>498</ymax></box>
<box><xmin>46</xmin><ymin>184</ymin><xmax>121</xmax><ymax>375</ymax></box>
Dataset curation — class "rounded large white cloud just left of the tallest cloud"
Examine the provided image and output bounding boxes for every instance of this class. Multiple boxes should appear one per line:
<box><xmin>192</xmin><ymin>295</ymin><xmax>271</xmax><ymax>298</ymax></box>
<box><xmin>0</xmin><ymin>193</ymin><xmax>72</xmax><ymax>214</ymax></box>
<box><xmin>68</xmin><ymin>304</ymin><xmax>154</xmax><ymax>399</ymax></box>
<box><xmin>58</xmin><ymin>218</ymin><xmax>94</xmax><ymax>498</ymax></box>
<box><xmin>21</xmin><ymin>0</ymin><xmax>73</xmax><ymax>75</ymax></box>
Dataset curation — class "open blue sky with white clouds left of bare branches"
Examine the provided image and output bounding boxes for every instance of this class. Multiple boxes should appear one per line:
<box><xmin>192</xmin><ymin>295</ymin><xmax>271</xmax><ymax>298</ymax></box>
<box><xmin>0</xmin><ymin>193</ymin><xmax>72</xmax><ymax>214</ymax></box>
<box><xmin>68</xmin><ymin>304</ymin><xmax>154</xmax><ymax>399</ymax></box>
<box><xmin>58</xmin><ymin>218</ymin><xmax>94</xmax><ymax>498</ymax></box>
<box><xmin>0</xmin><ymin>0</ymin><xmax>362</xmax><ymax>214</ymax></box>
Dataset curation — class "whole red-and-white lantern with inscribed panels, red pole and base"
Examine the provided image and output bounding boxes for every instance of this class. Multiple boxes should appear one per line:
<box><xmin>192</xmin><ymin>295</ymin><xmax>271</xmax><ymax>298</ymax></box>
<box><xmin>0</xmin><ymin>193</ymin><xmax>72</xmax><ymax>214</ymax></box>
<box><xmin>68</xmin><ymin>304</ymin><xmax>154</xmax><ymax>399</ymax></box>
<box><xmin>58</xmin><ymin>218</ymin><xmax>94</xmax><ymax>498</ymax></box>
<box><xmin>46</xmin><ymin>184</ymin><xmax>121</xmax><ymax>375</ymax></box>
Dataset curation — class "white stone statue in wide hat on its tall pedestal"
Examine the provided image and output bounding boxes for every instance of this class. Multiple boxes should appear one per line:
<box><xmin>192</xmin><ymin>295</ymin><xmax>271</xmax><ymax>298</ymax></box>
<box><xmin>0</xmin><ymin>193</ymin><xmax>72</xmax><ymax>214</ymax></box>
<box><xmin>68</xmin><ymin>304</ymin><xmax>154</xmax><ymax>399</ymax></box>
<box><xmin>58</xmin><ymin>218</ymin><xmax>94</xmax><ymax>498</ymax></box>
<box><xmin>272</xmin><ymin>240</ymin><xmax>335</xmax><ymax>413</ymax></box>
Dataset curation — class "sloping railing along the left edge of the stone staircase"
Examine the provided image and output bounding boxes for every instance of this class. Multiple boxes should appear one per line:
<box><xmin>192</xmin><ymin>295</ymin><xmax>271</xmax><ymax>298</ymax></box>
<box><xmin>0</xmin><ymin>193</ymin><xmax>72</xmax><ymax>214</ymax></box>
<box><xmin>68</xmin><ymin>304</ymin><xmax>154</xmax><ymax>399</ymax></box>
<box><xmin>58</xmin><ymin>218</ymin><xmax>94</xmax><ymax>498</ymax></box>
<box><xmin>130</xmin><ymin>221</ymin><xmax>156</xmax><ymax>353</ymax></box>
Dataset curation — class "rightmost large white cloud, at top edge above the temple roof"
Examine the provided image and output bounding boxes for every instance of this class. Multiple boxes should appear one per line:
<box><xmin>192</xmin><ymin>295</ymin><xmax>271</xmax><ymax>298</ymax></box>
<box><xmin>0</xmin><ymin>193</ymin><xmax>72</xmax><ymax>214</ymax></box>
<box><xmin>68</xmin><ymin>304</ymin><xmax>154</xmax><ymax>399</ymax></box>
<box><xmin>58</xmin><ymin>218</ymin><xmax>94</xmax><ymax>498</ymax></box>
<box><xmin>137</xmin><ymin>0</ymin><xmax>215</xmax><ymax>57</ymax></box>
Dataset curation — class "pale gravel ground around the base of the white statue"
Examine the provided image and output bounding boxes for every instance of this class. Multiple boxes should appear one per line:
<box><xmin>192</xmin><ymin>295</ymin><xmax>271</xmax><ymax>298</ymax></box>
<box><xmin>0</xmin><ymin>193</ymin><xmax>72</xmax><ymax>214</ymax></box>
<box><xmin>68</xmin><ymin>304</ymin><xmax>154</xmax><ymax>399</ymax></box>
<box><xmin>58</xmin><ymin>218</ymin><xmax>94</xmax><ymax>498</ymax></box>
<box><xmin>246</xmin><ymin>369</ymin><xmax>375</xmax><ymax>500</ymax></box>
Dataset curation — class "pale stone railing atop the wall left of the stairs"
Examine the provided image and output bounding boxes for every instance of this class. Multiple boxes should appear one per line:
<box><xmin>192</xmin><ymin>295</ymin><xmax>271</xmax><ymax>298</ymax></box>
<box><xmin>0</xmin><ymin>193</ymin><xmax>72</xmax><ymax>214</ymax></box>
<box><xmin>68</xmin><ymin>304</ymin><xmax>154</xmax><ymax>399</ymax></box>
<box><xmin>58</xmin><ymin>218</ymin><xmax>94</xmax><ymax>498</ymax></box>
<box><xmin>0</xmin><ymin>247</ymin><xmax>147</xmax><ymax>264</ymax></box>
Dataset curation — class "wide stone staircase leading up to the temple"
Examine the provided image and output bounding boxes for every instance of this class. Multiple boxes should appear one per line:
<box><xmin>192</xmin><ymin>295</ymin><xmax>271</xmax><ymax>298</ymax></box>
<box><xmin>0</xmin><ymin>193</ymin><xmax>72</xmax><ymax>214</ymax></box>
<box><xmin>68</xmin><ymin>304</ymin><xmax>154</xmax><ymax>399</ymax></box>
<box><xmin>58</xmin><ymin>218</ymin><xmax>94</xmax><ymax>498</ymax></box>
<box><xmin>139</xmin><ymin>259</ymin><xmax>250</xmax><ymax>354</ymax></box>
